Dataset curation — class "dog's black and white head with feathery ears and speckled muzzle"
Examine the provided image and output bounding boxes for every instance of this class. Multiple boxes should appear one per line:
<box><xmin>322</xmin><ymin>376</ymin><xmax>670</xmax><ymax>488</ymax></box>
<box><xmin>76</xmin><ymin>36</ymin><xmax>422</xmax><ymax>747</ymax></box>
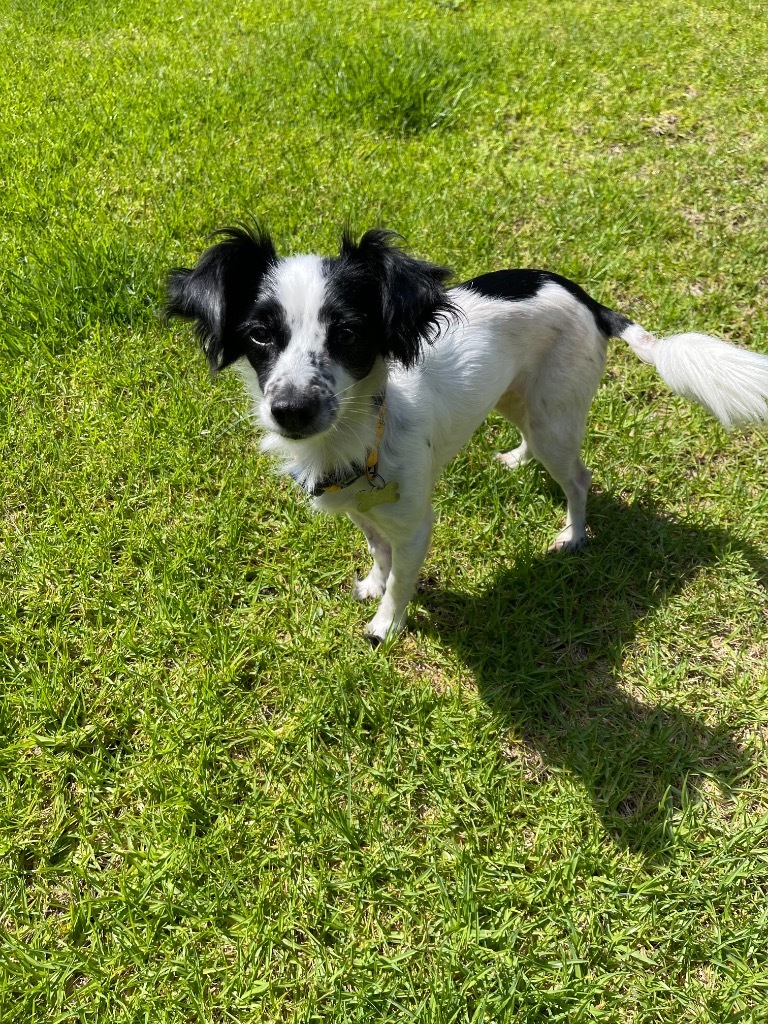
<box><xmin>167</xmin><ymin>228</ymin><xmax>454</xmax><ymax>438</ymax></box>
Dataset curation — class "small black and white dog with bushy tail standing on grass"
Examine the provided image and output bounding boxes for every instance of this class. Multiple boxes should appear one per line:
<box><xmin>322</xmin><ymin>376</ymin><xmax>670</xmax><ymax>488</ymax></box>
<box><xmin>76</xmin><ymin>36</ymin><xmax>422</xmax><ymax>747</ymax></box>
<box><xmin>168</xmin><ymin>228</ymin><xmax>768</xmax><ymax>641</ymax></box>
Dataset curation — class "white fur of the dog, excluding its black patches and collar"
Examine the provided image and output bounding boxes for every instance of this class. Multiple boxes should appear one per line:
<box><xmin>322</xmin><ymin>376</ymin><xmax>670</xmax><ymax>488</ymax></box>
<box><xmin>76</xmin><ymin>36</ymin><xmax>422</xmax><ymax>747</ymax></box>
<box><xmin>237</xmin><ymin>257</ymin><xmax>768</xmax><ymax>640</ymax></box>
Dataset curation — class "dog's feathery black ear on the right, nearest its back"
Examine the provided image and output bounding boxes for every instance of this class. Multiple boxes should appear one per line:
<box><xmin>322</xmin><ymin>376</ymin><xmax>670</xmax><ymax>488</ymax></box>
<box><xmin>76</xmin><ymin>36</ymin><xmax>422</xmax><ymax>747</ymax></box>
<box><xmin>340</xmin><ymin>228</ymin><xmax>457</xmax><ymax>367</ymax></box>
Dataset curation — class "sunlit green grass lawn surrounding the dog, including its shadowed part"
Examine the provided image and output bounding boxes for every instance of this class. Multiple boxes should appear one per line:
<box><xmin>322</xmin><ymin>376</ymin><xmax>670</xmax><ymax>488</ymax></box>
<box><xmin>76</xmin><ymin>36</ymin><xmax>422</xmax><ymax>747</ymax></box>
<box><xmin>0</xmin><ymin>0</ymin><xmax>768</xmax><ymax>1024</ymax></box>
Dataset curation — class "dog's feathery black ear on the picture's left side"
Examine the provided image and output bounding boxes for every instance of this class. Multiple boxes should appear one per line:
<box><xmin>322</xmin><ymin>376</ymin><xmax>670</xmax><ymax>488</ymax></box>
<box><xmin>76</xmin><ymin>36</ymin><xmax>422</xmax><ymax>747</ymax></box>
<box><xmin>166</xmin><ymin>227</ymin><xmax>278</xmax><ymax>372</ymax></box>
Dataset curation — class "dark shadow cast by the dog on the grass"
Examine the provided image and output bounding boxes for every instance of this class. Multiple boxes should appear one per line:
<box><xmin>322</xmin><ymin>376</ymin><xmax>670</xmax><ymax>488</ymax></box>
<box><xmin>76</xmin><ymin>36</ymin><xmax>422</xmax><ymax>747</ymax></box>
<box><xmin>421</xmin><ymin>494</ymin><xmax>768</xmax><ymax>857</ymax></box>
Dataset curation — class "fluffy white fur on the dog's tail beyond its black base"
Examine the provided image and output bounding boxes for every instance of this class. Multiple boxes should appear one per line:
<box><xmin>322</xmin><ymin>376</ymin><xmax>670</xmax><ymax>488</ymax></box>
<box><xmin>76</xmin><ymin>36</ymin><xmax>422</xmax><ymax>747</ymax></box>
<box><xmin>618</xmin><ymin>324</ymin><xmax>768</xmax><ymax>427</ymax></box>
